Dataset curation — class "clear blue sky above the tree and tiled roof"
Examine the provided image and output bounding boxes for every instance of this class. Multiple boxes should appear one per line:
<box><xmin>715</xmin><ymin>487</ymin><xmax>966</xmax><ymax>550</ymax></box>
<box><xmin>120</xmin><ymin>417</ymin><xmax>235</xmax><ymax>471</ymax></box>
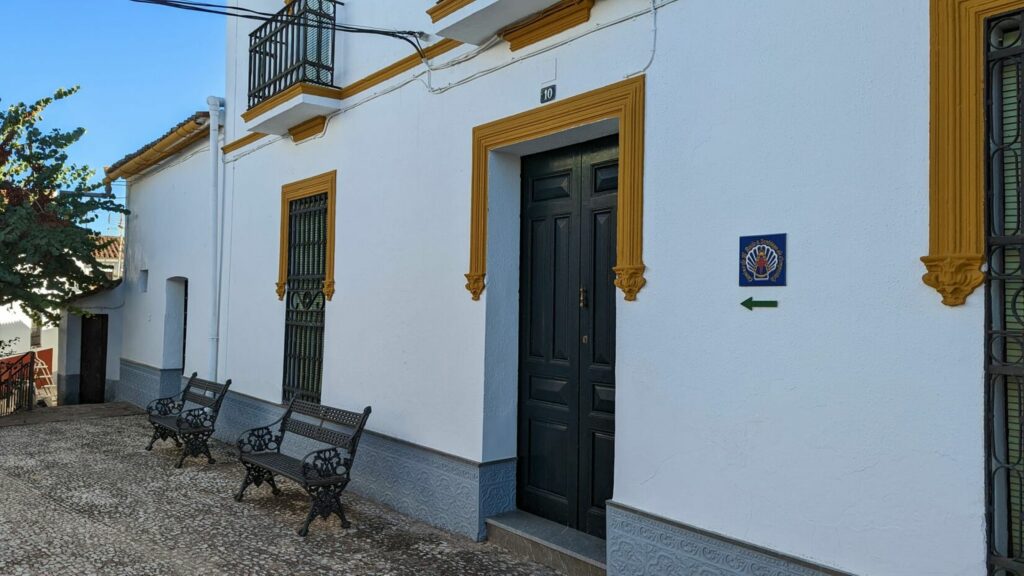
<box><xmin>0</xmin><ymin>0</ymin><xmax>224</xmax><ymax>234</ymax></box>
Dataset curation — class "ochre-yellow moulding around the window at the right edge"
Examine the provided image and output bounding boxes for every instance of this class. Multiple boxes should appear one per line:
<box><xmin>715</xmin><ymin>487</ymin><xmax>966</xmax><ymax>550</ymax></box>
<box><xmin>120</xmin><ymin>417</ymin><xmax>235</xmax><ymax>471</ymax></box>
<box><xmin>921</xmin><ymin>0</ymin><xmax>1024</xmax><ymax>306</ymax></box>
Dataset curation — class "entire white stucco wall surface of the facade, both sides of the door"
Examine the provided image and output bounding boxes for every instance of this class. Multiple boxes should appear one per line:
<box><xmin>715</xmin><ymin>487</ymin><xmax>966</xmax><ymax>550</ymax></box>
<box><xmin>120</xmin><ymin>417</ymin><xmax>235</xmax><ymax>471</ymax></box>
<box><xmin>110</xmin><ymin>0</ymin><xmax>985</xmax><ymax>575</ymax></box>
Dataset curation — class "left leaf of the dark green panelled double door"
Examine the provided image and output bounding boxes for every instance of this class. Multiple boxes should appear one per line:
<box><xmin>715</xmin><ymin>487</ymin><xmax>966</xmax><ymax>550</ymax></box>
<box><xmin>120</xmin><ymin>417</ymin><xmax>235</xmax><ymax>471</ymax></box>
<box><xmin>517</xmin><ymin>143</ymin><xmax>580</xmax><ymax>524</ymax></box>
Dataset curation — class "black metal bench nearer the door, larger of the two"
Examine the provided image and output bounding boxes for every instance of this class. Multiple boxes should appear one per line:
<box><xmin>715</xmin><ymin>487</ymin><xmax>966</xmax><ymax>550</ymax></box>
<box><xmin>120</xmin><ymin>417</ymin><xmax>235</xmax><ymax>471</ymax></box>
<box><xmin>234</xmin><ymin>400</ymin><xmax>371</xmax><ymax>536</ymax></box>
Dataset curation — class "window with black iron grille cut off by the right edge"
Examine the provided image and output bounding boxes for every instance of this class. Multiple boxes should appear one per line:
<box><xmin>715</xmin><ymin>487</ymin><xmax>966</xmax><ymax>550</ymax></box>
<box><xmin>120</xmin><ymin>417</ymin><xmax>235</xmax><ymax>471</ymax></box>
<box><xmin>985</xmin><ymin>12</ymin><xmax>1024</xmax><ymax>576</ymax></box>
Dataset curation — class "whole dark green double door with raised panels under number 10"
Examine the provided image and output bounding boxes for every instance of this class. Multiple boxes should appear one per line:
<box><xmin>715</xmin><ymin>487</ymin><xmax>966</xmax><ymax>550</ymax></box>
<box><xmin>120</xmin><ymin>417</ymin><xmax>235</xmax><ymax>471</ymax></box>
<box><xmin>516</xmin><ymin>136</ymin><xmax>618</xmax><ymax>538</ymax></box>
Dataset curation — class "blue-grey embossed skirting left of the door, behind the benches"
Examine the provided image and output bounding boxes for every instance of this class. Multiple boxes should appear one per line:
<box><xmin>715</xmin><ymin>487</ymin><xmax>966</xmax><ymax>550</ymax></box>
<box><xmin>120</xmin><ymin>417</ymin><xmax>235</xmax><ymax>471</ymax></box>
<box><xmin>118</xmin><ymin>361</ymin><xmax>515</xmax><ymax>540</ymax></box>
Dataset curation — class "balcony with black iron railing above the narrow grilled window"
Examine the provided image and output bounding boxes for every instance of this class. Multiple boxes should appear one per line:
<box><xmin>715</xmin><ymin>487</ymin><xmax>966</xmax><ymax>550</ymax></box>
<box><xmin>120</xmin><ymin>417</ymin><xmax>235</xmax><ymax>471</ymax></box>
<box><xmin>242</xmin><ymin>0</ymin><xmax>341</xmax><ymax>134</ymax></box>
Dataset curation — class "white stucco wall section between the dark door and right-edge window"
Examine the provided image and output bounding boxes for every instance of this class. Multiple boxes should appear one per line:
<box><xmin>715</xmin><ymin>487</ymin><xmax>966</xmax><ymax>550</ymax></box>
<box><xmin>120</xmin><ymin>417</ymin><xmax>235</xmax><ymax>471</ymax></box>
<box><xmin>615</xmin><ymin>1</ymin><xmax>984</xmax><ymax>575</ymax></box>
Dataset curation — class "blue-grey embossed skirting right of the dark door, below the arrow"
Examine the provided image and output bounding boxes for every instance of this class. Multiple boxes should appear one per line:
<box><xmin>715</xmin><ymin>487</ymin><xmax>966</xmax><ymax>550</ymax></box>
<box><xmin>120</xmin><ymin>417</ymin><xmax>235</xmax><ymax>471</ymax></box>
<box><xmin>607</xmin><ymin>502</ymin><xmax>849</xmax><ymax>576</ymax></box>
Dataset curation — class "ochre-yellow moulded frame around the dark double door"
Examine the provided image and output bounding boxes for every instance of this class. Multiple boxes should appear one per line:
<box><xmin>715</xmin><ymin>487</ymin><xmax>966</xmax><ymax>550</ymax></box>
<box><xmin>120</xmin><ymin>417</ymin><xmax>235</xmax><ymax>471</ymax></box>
<box><xmin>466</xmin><ymin>76</ymin><xmax>647</xmax><ymax>300</ymax></box>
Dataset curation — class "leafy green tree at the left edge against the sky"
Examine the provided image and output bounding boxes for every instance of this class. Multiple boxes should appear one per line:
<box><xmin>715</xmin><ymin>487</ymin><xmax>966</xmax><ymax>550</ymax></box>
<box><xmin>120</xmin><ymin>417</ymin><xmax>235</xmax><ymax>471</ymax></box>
<box><xmin>0</xmin><ymin>86</ymin><xmax>126</xmax><ymax>323</ymax></box>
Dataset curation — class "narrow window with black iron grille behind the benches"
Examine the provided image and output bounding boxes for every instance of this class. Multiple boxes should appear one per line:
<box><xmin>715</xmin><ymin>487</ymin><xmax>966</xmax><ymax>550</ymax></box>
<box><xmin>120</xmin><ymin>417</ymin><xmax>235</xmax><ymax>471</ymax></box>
<box><xmin>283</xmin><ymin>193</ymin><xmax>328</xmax><ymax>403</ymax></box>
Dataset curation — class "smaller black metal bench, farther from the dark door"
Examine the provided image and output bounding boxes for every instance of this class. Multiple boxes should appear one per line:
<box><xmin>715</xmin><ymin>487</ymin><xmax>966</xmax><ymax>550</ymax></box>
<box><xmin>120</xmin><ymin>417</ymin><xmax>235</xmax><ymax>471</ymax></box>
<box><xmin>145</xmin><ymin>372</ymin><xmax>231</xmax><ymax>468</ymax></box>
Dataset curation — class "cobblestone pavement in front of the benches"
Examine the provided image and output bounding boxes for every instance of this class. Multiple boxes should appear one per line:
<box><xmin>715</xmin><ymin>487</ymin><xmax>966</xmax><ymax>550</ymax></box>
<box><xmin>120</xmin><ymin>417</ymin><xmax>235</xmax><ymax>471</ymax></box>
<box><xmin>0</xmin><ymin>416</ymin><xmax>554</xmax><ymax>576</ymax></box>
